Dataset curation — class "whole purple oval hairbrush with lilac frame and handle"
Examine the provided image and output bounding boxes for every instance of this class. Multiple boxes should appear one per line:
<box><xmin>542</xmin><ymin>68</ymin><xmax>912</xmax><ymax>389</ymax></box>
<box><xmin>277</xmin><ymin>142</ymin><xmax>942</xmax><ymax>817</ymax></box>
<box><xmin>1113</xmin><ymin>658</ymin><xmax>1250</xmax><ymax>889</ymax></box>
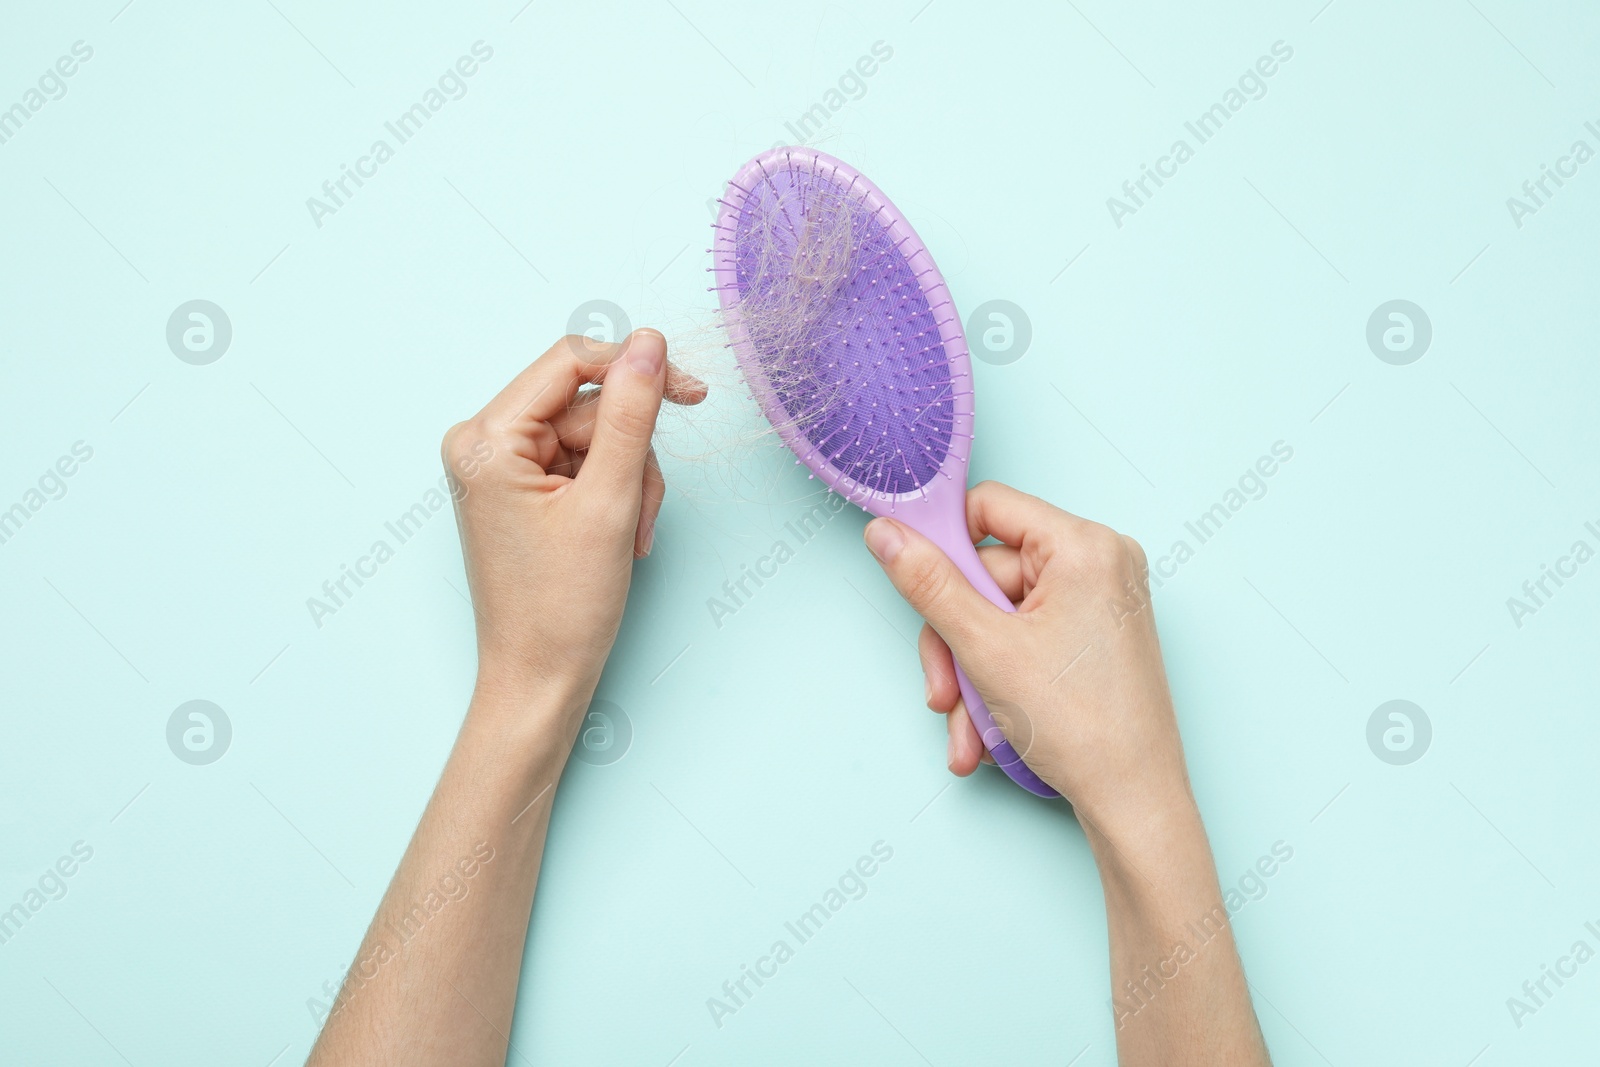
<box><xmin>712</xmin><ymin>147</ymin><xmax>1058</xmax><ymax>797</ymax></box>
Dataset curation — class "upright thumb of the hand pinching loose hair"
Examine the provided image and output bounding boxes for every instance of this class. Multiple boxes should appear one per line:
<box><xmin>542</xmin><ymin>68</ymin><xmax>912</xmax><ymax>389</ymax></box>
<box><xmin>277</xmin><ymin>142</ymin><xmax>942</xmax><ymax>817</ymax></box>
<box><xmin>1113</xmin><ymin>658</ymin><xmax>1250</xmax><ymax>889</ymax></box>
<box><xmin>579</xmin><ymin>330</ymin><xmax>667</xmax><ymax>501</ymax></box>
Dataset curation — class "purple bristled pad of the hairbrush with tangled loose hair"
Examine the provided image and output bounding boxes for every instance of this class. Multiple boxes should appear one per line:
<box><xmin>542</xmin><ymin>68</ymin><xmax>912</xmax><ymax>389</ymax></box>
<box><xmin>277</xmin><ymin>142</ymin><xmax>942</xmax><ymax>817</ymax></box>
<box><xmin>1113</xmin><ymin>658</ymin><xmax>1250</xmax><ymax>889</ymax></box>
<box><xmin>725</xmin><ymin>157</ymin><xmax>955</xmax><ymax>494</ymax></box>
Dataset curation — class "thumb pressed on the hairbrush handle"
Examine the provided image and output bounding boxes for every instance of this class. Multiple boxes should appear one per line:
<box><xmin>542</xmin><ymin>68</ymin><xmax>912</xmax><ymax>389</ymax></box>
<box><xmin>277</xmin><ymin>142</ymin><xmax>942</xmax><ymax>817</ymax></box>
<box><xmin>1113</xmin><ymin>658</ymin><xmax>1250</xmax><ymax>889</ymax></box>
<box><xmin>866</xmin><ymin>518</ymin><xmax>1005</xmax><ymax>661</ymax></box>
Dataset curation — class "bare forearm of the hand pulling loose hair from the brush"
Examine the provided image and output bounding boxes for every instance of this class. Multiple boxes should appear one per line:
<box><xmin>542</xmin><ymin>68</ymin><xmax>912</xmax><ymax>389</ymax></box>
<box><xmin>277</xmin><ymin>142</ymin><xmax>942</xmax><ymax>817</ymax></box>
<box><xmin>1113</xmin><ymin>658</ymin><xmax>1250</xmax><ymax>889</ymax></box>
<box><xmin>307</xmin><ymin>689</ymin><xmax>576</xmax><ymax>1067</ymax></box>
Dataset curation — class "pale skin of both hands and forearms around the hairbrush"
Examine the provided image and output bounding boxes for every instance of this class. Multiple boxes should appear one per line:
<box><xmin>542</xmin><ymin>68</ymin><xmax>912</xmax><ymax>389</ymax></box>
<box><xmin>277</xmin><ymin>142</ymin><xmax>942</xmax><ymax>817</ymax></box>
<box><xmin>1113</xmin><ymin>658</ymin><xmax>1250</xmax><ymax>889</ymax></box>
<box><xmin>307</xmin><ymin>330</ymin><xmax>1269</xmax><ymax>1067</ymax></box>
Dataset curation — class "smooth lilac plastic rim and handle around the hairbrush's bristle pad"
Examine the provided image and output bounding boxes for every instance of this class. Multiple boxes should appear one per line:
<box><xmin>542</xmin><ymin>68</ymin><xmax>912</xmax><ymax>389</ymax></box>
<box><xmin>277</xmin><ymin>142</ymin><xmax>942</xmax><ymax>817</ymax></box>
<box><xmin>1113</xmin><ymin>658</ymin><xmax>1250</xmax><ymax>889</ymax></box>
<box><xmin>712</xmin><ymin>146</ymin><xmax>1059</xmax><ymax>797</ymax></box>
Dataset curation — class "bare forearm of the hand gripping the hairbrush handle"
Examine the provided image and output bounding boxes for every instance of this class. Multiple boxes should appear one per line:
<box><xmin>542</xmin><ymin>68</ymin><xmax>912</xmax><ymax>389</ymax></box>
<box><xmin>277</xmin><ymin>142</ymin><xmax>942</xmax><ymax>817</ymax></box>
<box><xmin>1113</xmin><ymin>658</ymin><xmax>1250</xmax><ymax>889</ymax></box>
<box><xmin>1088</xmin><ymin>797</ymin><xmax>1269</xmax><ymax>1067</ymax></box>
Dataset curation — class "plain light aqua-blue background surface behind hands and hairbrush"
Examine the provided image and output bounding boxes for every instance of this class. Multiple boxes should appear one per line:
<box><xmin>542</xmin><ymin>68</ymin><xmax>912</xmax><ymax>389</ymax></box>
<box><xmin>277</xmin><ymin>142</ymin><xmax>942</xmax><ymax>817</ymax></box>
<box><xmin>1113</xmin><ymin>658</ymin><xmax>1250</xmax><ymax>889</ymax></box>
<box><xmin>0</xmin><ymin>0</ymin><xmax>1600</xmax><ymax>1067</ymax></box>
